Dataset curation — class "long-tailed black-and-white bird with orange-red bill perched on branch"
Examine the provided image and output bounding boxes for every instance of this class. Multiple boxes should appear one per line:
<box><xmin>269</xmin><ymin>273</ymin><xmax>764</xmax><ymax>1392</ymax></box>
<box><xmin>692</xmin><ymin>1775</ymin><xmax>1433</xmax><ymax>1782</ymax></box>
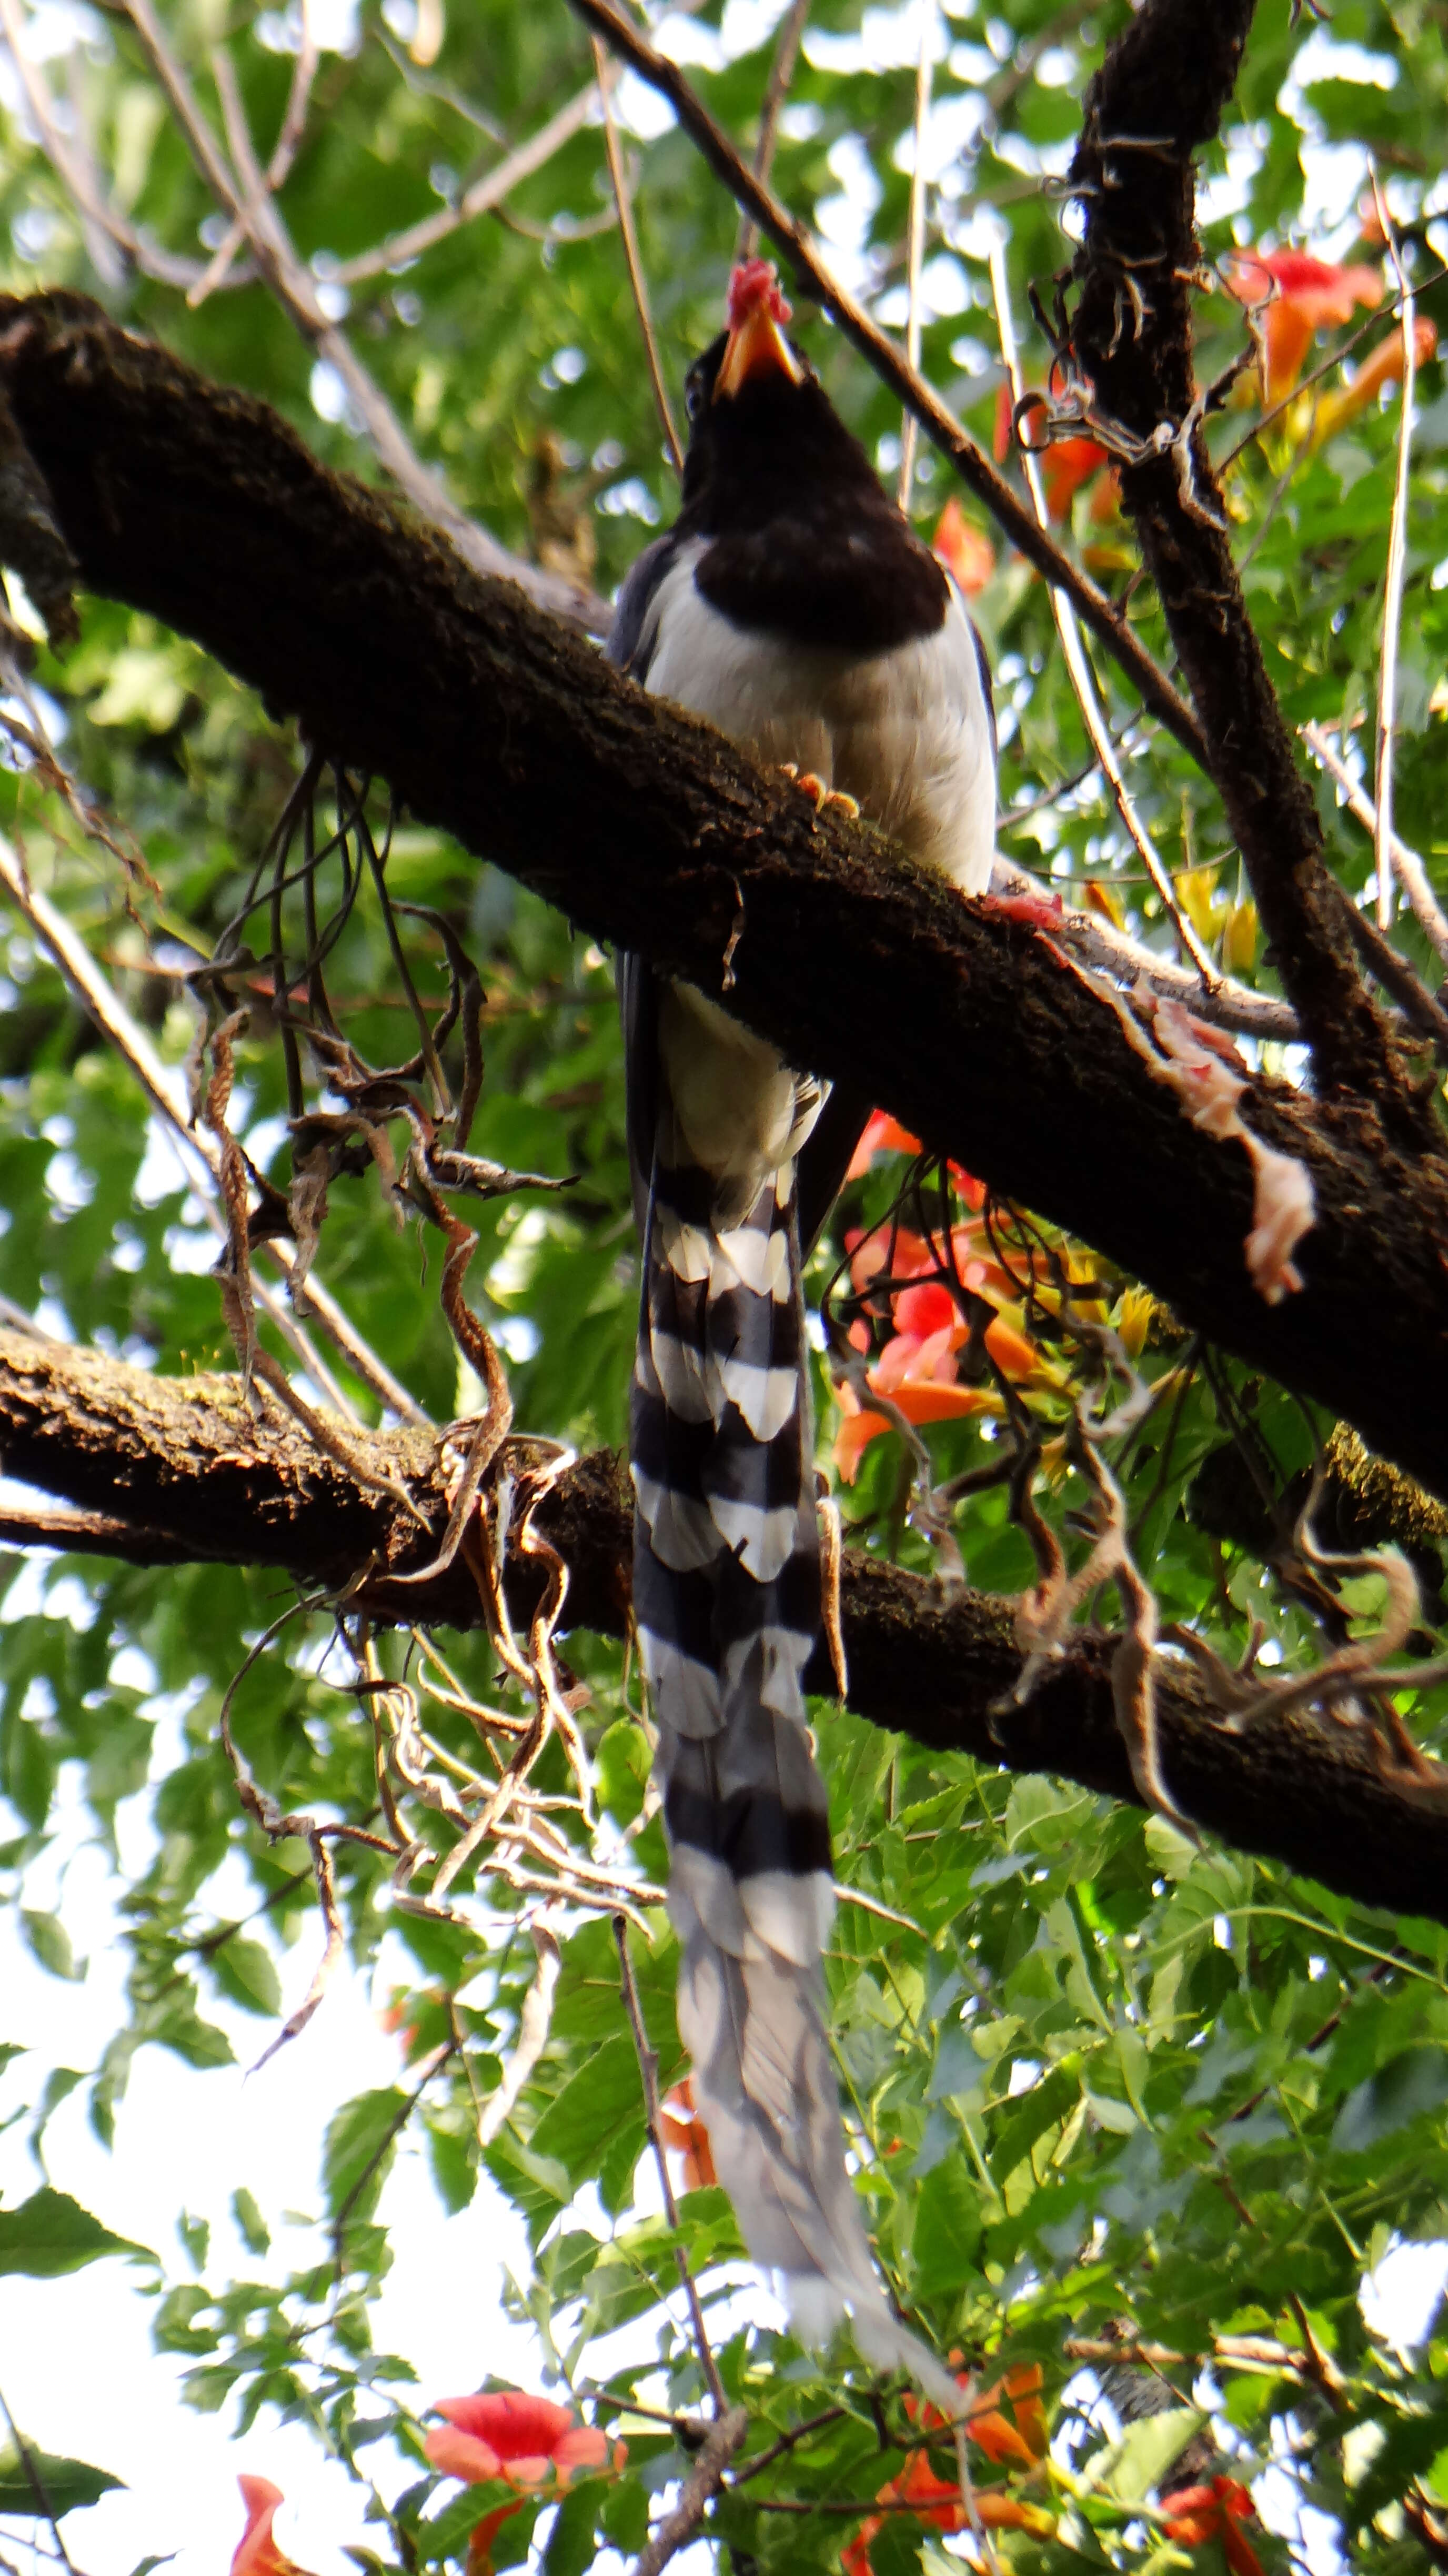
<box><xmin>611</xmin><ymin>260</ymin><xmax>994</xmax><ymax>2403</ymax></box>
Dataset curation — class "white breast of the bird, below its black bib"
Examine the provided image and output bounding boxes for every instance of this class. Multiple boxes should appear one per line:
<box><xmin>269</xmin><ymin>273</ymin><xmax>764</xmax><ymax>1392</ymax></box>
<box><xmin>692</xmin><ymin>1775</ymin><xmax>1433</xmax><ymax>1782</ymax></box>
<box><xmin>644</xmin><ymin>538</ymin><xmax>994</xmax><ymax>894</ymax></box>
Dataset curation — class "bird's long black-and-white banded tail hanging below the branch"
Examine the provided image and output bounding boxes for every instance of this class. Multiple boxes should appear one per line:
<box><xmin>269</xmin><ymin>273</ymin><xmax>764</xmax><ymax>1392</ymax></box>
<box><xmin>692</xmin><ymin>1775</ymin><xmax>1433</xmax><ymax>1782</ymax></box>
<box><xmin>631</xmin><ymin>1110</ymin><xmax>959</xmax><ymax>2411</ymax></box>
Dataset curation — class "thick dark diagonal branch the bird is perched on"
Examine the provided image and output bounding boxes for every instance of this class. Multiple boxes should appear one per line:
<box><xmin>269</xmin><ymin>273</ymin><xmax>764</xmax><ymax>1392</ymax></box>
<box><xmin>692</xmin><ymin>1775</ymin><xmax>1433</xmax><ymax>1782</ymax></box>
<box><xmin>0</xmin><ymin>294</ymin><xmax>1448</xmax><ymax>1492</ymax></box>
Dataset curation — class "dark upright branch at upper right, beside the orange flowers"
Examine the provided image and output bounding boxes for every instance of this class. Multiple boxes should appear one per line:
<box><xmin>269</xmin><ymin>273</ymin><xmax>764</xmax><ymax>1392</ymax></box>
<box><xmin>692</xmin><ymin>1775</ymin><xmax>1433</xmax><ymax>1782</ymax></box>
<box><xmin>1069</xmin><ymin>0</ymin><xmax>1435</xmax><ymax>1144</ymax></box>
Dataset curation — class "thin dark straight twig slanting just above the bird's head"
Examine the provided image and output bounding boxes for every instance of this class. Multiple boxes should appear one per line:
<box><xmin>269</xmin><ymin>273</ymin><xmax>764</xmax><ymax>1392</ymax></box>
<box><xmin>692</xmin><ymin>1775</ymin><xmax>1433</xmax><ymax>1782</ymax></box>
<box><xmin>569</xmin><ymin>0</ymin><xmax>1211</xmax><ymax>770</ymax></box>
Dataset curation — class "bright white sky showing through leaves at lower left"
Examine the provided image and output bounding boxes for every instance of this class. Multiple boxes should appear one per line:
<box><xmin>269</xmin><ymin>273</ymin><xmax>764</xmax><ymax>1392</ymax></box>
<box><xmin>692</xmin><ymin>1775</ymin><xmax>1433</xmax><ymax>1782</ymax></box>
<box><xmin>0</xmin><ymin>1558</ymin><xmax>721</xmax><ymax>2576</ymax></box>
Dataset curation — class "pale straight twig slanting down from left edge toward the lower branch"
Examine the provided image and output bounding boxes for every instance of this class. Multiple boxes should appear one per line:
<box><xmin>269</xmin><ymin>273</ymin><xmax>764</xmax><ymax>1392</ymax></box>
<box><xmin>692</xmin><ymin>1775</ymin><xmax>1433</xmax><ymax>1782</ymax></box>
<box><xmin>0</xmin><ymin>834</ymin><xmax>428</xmax><ymax>1422</ymax></box>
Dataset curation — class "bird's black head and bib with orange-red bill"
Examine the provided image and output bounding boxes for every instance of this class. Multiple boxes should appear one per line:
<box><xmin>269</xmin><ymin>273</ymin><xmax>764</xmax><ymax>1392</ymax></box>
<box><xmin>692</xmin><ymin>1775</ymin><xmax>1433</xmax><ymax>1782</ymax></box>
<box><xmin>678</xmin><ymin>260</ymin><xmax>948</xmax><ymax>652</ymax></box>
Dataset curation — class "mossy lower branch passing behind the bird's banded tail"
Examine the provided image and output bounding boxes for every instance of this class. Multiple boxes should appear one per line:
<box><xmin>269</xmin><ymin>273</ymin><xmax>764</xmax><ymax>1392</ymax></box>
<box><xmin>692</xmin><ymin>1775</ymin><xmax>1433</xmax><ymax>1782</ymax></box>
<box><xmin>0</xmin><ymin>1326</ymin><xmax>1448</xmax><ymax>1921</ymax></box>
